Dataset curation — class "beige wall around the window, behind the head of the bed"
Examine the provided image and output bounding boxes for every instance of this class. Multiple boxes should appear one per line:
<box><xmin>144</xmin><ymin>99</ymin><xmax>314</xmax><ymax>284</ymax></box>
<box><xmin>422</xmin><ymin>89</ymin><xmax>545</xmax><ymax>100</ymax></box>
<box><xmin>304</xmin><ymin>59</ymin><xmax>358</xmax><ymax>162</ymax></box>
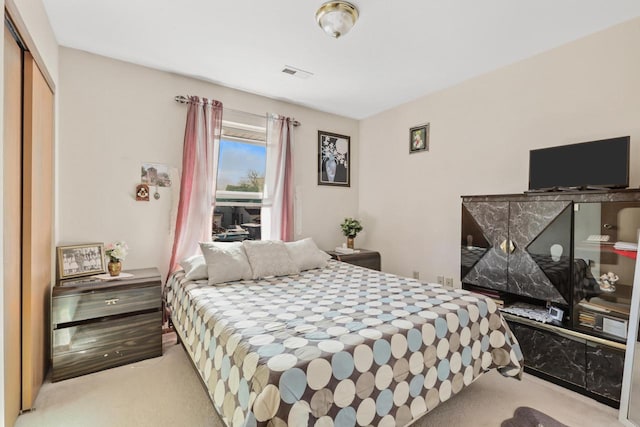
<box><xmin>58</xmin><ymin>48</ymin><xmax>358</xmax><ymax>280</ymax></box>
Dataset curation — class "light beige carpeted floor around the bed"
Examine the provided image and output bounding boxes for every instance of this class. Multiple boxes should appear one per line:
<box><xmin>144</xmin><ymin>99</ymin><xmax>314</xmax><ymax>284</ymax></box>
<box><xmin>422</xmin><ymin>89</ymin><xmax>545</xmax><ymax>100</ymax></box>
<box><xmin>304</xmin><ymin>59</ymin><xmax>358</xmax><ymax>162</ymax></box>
<box><xmin>16</xmin><ymin>341</ymin><xmax>621</xmax><ymax>427</ymax></box>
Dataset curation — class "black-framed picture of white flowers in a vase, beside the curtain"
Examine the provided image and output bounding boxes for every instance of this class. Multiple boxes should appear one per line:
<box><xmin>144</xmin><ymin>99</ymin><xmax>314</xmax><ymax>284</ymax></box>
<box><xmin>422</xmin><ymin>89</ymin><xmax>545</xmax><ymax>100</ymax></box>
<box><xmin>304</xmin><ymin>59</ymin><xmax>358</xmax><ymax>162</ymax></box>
<box><xmin>318</xmin><ymin>130</ymin><xmax>351</xmax><ymax>187</ymax></box>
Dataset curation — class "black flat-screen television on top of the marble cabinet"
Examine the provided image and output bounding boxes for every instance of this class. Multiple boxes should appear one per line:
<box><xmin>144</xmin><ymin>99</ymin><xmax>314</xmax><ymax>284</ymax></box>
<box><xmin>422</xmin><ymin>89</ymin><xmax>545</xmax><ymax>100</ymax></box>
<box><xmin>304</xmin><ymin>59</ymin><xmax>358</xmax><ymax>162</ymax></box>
<box><xmin>529</xmin><ymin>136</ymin><xmax>630</xmax><ymax>191</ymax></box>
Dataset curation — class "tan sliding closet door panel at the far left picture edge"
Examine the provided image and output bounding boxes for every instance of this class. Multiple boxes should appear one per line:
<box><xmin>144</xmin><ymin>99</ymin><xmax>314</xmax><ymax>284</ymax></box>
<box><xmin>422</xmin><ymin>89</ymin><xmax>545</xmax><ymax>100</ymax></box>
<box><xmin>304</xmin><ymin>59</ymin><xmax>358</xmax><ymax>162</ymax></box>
<box><xmin>2</xmin><ymin>26</ymin><xmax>22</xmax><ymax>426</ymax></box>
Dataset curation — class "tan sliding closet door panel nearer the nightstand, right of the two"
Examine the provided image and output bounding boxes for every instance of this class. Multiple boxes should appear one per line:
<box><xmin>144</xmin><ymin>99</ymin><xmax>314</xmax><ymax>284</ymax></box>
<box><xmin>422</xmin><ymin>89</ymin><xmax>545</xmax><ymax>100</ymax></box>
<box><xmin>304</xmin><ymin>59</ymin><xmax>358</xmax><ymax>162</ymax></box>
<box><xmin>22</xmin><ymin>52</ymin><xmax>54</xmax><ymax>409</ymax></box>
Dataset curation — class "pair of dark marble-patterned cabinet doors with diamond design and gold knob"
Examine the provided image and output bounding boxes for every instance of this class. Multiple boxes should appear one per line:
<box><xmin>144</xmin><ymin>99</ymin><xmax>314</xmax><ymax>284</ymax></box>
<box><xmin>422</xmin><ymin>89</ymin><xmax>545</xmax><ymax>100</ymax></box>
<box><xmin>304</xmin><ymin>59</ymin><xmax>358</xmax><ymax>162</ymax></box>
<box><xmin>461</xmin><ymin>201</ymin><xmax>571</xmax><ymax>305</ymax></box>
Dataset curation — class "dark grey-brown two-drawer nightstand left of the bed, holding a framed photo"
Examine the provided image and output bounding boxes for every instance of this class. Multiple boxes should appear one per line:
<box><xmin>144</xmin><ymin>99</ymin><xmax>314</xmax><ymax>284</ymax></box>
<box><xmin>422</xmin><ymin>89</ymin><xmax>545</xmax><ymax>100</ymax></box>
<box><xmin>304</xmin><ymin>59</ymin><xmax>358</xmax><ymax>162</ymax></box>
<box><xmin>51</xmin><ymin>268</ymin><xmax>162</xmax><ymax>381</ymax></box>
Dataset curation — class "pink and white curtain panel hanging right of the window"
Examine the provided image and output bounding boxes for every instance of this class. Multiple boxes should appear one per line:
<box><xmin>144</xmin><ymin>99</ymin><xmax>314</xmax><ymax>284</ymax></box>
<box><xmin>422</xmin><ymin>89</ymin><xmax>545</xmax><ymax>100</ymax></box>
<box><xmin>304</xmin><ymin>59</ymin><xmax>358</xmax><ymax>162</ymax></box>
<box><xmin>260</xmin><ymin>115</ymin><xmax>293</xmax><ymax>242</ymax></box>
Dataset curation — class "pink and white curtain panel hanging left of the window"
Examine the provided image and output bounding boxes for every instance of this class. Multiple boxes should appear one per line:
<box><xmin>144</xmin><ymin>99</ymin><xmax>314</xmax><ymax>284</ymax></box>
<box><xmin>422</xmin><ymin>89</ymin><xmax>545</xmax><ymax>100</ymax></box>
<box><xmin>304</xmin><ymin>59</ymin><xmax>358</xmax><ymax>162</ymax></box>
<box><xmin>169</xmin><ymin>96</ymin><xmax>222</xmax><ymax>274</ymax></box>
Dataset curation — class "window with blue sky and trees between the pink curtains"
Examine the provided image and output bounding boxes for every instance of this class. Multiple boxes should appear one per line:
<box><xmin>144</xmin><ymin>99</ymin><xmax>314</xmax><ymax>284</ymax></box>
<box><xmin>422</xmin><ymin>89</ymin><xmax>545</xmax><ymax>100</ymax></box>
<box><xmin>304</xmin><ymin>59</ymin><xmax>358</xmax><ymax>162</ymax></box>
<box><xmin>214</xmin><ymin>110</ymin><xmax>267</xmax><ymax>239</ymax></box>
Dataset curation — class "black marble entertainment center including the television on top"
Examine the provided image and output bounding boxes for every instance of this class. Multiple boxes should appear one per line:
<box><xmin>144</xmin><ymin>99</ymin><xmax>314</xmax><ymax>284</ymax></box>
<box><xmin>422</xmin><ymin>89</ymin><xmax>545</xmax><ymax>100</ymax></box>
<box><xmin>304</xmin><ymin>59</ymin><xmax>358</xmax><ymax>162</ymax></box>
<box><xmin>460</xmin><ymin>137</ymin><xmax>640</xmax><ymax>407</ymax></box>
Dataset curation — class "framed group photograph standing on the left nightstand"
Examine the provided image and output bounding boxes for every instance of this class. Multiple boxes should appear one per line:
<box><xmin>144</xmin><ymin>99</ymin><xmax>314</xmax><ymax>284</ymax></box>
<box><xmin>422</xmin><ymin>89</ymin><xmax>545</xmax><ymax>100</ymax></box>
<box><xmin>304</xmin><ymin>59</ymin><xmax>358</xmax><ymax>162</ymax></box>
<box><xmin>57</xmin><ymin>243</ymin><xmax>106</xmax><ymax>280</ymax></box>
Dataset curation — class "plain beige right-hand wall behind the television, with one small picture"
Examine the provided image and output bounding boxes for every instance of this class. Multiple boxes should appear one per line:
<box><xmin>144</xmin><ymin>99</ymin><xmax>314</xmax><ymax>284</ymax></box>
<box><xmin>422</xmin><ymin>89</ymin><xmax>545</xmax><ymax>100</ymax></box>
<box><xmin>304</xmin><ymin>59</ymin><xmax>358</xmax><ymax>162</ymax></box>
<box><xmin>359</xmin><ymin>19</ymin><xmax>640</xmax><ymax>284</ymax></box>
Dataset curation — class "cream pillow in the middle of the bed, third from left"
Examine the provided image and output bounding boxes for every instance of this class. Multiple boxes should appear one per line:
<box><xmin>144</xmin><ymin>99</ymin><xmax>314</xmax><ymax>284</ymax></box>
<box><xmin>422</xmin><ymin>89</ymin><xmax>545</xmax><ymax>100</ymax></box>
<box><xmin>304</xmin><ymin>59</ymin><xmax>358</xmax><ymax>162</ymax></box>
<box><xmin>242</xmin><ymin>240</ymin><xmax>300</xmax><ymax>279</ymax></box>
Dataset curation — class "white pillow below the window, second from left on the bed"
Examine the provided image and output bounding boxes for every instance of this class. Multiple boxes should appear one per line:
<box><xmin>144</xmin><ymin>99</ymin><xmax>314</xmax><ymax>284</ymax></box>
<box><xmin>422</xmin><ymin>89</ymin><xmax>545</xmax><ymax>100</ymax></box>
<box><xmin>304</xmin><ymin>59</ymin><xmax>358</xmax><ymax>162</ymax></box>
<box><xmin>200</xmin><ymin>242</ymin><xmax>252</xmax><ymax>285</ymax></box>
